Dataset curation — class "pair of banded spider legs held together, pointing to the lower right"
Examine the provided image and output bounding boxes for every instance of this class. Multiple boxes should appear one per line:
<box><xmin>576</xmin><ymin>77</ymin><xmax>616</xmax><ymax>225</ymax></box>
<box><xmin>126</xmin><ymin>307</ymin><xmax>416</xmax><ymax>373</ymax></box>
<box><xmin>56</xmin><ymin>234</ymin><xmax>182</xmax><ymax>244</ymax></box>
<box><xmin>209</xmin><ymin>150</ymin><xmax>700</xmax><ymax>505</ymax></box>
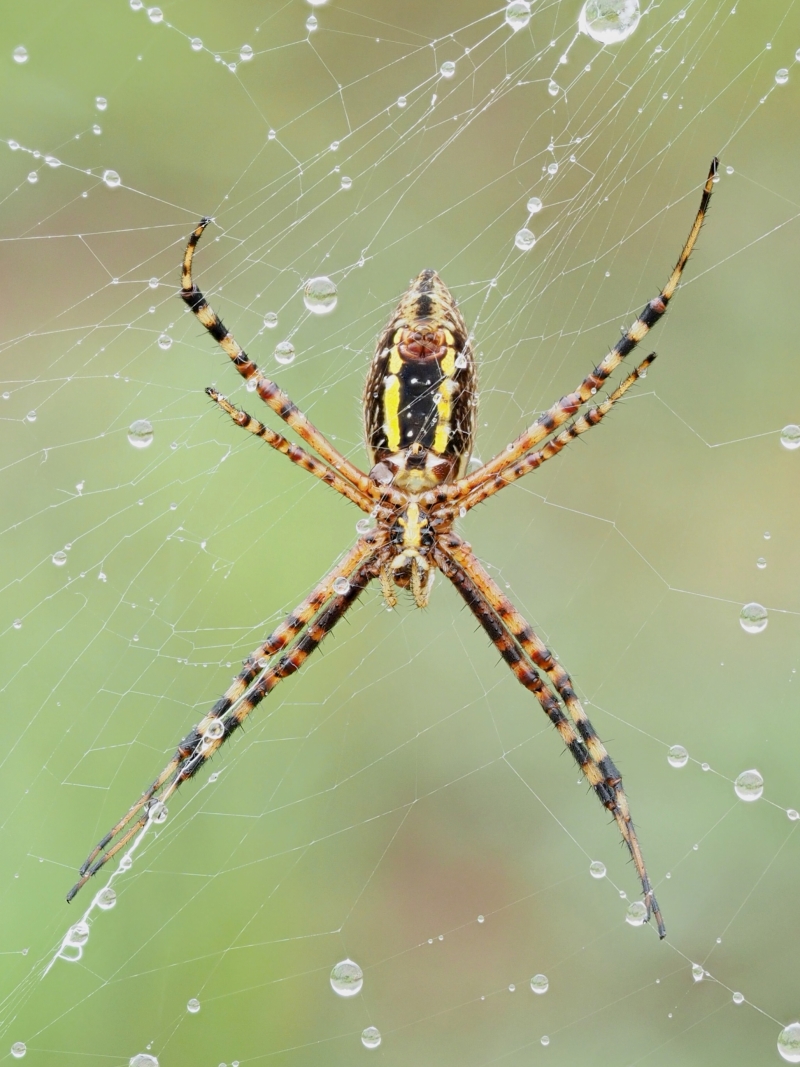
<box><xmin>435</xmin><ymin>535</ymin><xmax>667</xmax><ymax>938</ymax></box>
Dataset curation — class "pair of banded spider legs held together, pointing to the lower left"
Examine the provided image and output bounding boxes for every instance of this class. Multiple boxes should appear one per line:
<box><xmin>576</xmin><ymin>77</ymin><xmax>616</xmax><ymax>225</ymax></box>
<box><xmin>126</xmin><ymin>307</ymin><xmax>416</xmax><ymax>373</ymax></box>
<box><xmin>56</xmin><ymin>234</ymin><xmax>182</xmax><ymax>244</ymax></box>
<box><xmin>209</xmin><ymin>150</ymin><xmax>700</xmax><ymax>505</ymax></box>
<box><xmin>66</xmin><ymin>542</ymin><xmax>384</xmax><ymax>902</ymax></box>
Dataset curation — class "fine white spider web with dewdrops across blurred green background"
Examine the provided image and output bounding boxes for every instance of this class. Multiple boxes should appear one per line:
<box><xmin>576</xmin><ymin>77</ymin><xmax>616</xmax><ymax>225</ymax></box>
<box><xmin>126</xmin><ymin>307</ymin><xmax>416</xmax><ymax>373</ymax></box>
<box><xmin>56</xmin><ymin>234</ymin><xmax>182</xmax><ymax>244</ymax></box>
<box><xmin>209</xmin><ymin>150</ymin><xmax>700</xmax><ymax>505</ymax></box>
<box><xmin>0</xmin><ymin>0</ymin><xmax>800</xmax><ymax>1067</ymax></box>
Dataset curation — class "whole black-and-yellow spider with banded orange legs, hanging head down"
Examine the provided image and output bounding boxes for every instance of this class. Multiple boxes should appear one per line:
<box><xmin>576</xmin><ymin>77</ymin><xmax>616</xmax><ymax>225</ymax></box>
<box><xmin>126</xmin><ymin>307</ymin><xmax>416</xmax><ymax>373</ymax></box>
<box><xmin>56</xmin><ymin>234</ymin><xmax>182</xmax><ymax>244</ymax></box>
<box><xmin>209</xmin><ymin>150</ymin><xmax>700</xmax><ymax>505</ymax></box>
<box><xmin>67</xmin><ymin>159</ymin><xmax>718</xmax><ymax>938</ymax></box>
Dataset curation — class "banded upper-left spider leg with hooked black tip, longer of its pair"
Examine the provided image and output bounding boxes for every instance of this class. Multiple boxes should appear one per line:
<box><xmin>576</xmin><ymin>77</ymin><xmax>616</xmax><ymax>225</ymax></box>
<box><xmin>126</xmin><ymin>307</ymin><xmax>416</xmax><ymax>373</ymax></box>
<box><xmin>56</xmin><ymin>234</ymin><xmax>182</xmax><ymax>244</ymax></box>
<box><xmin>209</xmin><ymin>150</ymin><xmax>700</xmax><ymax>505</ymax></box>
<box><xmin>180</xmin><ymin>219</ymin><xmax>399</xmax><ymax>503</ymax></box>
